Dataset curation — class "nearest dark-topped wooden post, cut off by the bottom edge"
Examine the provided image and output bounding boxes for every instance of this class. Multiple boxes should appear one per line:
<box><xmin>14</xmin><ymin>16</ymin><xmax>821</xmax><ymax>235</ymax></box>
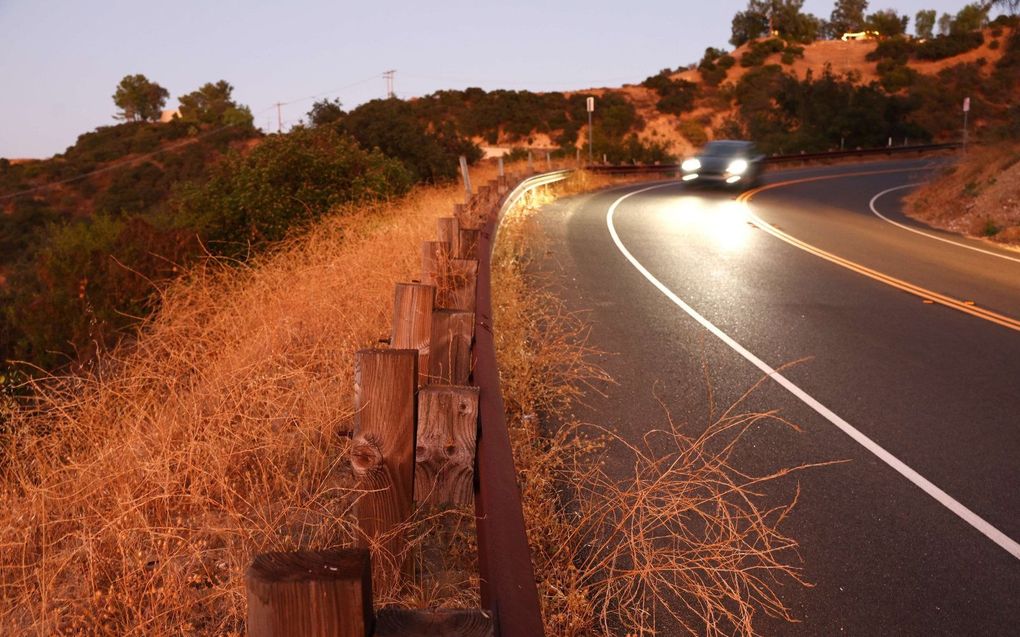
<box><xmin>245</xmin><ymin>548</ymin><xmax>374</xmax><ymax>637</ymax></box>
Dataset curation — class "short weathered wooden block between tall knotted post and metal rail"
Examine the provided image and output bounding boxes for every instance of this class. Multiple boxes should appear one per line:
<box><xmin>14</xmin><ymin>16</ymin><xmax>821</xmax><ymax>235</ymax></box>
<box><xmin>414</xmin><ymin>386</ymin><xmax>478</xmax><ymax>506</ymax></box>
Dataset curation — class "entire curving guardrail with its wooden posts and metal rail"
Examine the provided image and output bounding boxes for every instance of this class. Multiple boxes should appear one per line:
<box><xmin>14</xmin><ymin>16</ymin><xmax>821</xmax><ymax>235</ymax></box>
<box><xmin>245</xmin><ymin>170</ymin><xmax>570</xmax><ymax>637</ymax></box>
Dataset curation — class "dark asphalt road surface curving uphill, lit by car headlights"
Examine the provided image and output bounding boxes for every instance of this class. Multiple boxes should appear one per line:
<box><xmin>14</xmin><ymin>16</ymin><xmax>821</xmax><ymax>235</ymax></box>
<box><xmin>541</xmin><ymin>161</ymin><xmax>1020</xmax><ymax>635</ymax></box>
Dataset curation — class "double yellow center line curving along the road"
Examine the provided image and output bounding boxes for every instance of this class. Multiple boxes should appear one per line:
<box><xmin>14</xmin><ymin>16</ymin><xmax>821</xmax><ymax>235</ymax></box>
<box><xmin>736</xmin><ymin>168</ymin><xmax>1020</xmax><ymax>331</ymax></box>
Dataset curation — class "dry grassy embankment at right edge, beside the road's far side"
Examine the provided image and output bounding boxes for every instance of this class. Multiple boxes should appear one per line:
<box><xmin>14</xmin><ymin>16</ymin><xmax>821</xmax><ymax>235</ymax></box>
<box><xmin>906</xmin><ymin>143</ymin><xmax>1020</xmax><ymax>247</ymax></box>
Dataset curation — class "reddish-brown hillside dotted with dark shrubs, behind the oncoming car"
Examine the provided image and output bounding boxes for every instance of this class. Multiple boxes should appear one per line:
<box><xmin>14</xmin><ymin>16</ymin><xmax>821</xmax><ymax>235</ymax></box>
<box><xmin>452</xmin><ymin>17</ymin><xmax>1020</xmax><ymax>162</ymax></box>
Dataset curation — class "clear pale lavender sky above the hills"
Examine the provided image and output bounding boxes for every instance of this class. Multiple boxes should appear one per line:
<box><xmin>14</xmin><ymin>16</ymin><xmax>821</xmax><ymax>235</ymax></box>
<box><xmin>0</xmin><ymin>0</ymin><xmax>999</xmax><ymax>158</ymax></box>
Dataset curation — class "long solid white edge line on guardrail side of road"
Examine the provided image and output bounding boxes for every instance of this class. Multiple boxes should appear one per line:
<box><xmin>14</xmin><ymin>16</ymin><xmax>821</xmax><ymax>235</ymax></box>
<box><xmin>606</xmin><ymin>183</ymin><xmax>1020</xmax><ymax>560</ymax></box>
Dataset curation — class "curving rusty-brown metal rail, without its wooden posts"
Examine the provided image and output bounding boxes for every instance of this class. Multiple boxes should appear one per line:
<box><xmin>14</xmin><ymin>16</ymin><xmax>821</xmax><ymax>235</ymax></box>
<box><xmin>472</xmin><ymin>170</ymin><xmax>570</xmax><ymax>637</ymax></box>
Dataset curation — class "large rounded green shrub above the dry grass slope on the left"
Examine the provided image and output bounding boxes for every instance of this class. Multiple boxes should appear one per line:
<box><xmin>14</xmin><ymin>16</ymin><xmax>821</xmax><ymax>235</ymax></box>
<box><xmin>177</xmin><ymin>126</ymin><xmax>414</xmax><ymax>251</ymax></box>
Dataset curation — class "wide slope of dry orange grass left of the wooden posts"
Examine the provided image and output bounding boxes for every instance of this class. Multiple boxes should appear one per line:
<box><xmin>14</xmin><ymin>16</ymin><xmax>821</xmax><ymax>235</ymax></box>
<box><xmin>0</xmin><ymin>163</ymin><xmax>492</xmax><ymax>635</ymax></box>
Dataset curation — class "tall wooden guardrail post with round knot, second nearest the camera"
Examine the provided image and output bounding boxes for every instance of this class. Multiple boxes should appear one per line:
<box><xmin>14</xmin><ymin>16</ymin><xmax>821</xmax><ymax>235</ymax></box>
<box><xmin>351</xmin><ymin>350</ymin><xmax>418</xmax><ymax>588</ymax></box>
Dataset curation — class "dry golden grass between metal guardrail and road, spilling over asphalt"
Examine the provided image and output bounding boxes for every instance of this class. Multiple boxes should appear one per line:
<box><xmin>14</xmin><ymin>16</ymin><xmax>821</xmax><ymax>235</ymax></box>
<box><xmin>494</xmin><ymin>175</ymin><xmax>820</xmax><ymax>636</ymax></box>
